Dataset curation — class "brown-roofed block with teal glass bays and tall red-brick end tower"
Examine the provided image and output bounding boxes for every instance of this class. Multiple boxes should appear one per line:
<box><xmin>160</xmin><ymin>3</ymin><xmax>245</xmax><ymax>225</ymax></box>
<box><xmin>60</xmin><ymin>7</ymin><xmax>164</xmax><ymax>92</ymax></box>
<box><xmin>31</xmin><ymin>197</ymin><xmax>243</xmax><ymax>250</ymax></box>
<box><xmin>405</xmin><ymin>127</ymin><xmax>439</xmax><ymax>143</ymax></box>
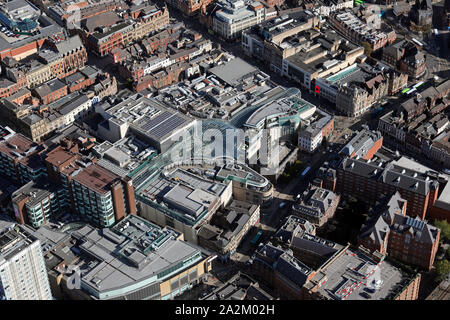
<box><xmin>45</xmin><ymin>146</ymin><xmax>136</xmax><ymax>227</ymax></box>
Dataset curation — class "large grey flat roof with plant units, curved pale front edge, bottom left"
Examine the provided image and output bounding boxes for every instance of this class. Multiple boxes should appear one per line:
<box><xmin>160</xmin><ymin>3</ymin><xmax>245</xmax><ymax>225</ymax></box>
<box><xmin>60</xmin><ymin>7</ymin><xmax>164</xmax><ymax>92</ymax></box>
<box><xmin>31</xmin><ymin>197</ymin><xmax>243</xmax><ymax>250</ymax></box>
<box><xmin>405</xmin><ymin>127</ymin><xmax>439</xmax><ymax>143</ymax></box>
<box><xmin>39</xmin><ymin>215</ymin><xmax>204</xmax><ymax>299</ymax></box>
